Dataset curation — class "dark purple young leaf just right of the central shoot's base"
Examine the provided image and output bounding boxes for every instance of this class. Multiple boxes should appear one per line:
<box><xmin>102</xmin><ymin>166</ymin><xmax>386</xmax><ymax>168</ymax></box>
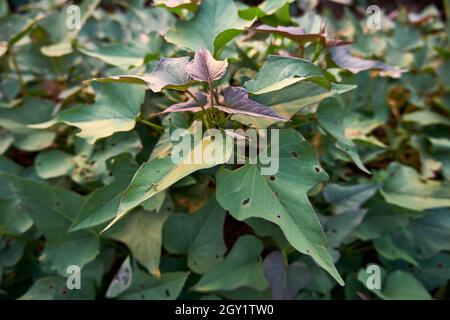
<box><xmin>217</xmin><ymin>87</ymin><xmax>288</xmax><ymax>121</ymax></box>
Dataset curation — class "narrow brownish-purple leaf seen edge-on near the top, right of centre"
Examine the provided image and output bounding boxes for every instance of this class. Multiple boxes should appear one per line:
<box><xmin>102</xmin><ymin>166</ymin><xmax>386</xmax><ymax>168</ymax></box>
<box><xmin>256</xmin><ymin>25</ymin><xmax>352</xmax><ymax>48</ymax></box>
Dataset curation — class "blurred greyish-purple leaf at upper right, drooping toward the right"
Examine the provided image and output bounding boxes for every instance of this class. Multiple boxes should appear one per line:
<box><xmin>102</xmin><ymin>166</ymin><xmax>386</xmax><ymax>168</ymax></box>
<box><xmin>331</xmin><ymin>47</ymin><xmax>407</xmax><ymax>78</ymax></box>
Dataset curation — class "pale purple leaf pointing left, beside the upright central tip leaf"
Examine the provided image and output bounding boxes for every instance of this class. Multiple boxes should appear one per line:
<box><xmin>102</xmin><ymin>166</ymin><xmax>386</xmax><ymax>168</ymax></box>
<box><xmin>87</xmin><ymin>57</ymin><xmax>193</xmax><ymax>92</ymax></box>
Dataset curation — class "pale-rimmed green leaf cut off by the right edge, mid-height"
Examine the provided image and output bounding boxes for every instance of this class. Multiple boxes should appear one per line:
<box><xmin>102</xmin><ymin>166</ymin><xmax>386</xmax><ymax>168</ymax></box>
<box><xmin>381</xmin><ymin>162</ymin><xmax>450</xmax><ymax>211</ymax></box>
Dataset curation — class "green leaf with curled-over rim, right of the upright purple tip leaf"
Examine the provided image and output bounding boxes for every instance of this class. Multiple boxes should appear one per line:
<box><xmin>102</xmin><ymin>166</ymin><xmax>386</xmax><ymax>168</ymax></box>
<box><xmin>244</xmin><ymin>55</ymin><xmax>330</xmax><ymax>95</ymax></box>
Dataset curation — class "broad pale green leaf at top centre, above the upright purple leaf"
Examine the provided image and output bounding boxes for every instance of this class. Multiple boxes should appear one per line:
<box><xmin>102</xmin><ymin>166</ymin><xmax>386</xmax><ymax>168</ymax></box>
<box><xmin>165</xmin><ymin>0</ymin><xmax>253</xmax><ymax>53</ymax></box>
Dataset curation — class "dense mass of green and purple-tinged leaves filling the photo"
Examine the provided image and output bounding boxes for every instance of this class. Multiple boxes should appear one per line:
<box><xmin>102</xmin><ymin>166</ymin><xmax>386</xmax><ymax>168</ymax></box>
<box><xmin>0</xmin><ymin>0</ymin><xmax>450</xmax><ymax>299</ymax></box>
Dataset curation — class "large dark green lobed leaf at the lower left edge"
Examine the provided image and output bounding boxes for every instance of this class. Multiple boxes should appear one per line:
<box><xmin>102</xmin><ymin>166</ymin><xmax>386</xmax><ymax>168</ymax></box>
<box><xmin>0</xmin><ymin>173</ymin><xmax>100</xmax><ymax>276</ymax></box>
